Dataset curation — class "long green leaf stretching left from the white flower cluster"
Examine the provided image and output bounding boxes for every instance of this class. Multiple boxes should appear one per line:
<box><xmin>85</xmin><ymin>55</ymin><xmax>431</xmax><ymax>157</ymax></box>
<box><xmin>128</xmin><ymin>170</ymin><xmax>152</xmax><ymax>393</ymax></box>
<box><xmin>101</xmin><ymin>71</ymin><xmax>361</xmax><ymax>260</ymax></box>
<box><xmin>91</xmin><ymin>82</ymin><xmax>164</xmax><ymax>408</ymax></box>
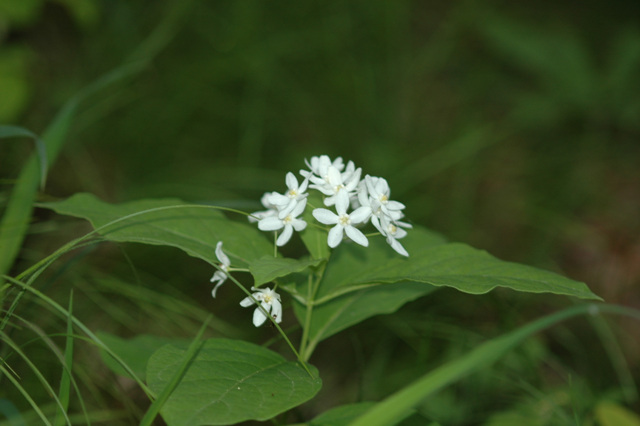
<box><xmin>42</xmin><ymin>194</ymin><xmax>273</xmax><ymax>266</ymax></box>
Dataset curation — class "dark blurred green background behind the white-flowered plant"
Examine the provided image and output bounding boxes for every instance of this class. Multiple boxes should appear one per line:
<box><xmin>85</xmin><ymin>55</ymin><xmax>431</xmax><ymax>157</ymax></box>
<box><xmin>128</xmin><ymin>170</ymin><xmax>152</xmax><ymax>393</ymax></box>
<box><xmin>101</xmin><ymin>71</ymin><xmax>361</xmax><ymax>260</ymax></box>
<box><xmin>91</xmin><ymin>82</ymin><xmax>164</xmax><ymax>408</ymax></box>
<box><xmin>0</xmin><ymin>0</ymin><xmax>640</xmax><ymax>424</ymax></box>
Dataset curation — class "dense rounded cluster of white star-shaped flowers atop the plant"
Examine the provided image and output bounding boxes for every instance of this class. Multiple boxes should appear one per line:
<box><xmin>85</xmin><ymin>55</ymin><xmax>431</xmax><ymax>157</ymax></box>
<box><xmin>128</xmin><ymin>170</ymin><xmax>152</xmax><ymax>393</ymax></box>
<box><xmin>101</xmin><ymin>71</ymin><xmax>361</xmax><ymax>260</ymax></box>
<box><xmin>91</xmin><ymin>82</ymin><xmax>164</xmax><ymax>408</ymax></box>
<box><xmin>249</xmin><ymin>155</ymin><xmax>411</xmax><ymax>256</ymax></box>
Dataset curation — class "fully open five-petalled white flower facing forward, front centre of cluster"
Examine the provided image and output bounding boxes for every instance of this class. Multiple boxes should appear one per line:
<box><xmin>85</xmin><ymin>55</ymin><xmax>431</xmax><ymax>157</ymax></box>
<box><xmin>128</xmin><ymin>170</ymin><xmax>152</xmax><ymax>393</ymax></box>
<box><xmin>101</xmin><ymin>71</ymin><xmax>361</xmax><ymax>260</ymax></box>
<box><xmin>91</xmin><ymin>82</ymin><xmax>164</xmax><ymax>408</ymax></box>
<box><xmin>313</xmin><ymin>192</ymin><xmax>371</xmax><ymax>248</ymax></box>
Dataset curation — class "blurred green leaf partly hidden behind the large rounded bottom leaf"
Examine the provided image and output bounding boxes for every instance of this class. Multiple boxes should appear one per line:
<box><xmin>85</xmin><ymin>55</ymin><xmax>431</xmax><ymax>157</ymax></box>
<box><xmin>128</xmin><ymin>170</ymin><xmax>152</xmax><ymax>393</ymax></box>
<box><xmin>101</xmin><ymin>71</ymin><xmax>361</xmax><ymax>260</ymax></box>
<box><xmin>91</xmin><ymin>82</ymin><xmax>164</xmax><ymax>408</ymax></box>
<box><xmin>96</xmin><ymin>333</ymin><xmax>189</xmax><ymax>380</ymax></box>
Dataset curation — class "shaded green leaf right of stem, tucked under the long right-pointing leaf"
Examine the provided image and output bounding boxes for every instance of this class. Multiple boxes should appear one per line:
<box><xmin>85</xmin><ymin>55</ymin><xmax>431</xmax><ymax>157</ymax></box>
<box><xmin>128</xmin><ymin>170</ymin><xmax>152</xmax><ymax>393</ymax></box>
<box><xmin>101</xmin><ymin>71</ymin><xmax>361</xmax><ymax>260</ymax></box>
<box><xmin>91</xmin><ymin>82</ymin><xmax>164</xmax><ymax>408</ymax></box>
<box><xmin>293</xmin><ymin>282</ymin><xmax>436</xmax><ymax>356</ymax></box>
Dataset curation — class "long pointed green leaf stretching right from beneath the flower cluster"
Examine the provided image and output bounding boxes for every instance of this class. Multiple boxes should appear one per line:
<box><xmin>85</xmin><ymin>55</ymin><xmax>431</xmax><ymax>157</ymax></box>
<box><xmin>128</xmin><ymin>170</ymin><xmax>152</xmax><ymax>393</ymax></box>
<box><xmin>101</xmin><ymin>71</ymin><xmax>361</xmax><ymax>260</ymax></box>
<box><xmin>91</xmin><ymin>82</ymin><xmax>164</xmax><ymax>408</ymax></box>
<box><xmin>318</xmin><ymin>227</ymin><xmax>600</xmax><ymax>300</ymax></box>
